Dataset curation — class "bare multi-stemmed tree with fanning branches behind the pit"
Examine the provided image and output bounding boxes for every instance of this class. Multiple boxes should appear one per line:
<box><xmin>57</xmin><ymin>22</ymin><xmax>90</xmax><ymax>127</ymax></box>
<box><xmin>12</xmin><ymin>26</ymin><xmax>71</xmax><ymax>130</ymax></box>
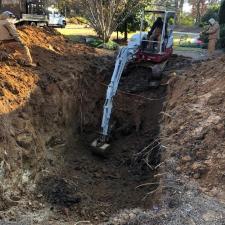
<box><xmin>81</xmin><ymin>0</ymin><xmax>145</xmax><ymax>43</ymax></box>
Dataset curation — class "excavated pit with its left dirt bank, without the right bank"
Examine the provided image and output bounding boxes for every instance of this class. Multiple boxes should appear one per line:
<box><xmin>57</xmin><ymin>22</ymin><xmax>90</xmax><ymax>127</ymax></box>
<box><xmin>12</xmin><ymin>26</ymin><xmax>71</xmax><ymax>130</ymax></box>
<box><xmin>0</xmin><ymin>27</ymin><xmax>193</xmax><ymax>224</ymax></box>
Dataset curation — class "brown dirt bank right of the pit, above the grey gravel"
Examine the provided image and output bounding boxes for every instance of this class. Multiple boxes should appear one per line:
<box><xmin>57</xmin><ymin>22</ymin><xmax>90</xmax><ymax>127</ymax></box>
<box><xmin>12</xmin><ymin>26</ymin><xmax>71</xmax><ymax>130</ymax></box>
<box><xmin>163</xmin><ymin>56</ymin><xmax>225</xmax><ymax>201</ymax></box>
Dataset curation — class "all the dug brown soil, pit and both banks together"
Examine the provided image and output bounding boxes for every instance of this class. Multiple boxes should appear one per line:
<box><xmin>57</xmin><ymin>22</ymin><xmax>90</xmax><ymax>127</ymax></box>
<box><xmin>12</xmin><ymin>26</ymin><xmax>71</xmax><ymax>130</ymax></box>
<box><xmin>0</xmin><ymin>27</ymin><xmax>225</xmax><ymax>225</ymax></box>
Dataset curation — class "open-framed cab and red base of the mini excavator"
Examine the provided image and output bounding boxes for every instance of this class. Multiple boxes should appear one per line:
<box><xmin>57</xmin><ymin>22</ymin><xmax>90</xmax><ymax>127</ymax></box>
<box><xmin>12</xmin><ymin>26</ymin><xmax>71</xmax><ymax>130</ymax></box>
<box><xmin>136</xmin><ymin>10</ymin><xmax>176</xmax><ymax>63</ymax></box>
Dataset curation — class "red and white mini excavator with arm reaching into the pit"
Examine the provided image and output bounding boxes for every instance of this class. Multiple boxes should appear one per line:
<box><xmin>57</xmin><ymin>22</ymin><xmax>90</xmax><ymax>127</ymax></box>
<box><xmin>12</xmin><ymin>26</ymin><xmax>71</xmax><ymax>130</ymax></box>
<box><xmin>91</xmin><ymin>7</ymin><xmax>176</xmax><ymax>155</ymax></box>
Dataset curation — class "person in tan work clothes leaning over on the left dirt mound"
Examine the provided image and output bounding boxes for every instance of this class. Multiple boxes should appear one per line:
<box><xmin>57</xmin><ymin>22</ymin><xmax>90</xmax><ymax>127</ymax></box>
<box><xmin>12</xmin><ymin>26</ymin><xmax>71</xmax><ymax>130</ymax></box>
<box><xmin>0</xmin><ymin>11</ymin><xmax>36</xmax><ymax>67</ymax></box>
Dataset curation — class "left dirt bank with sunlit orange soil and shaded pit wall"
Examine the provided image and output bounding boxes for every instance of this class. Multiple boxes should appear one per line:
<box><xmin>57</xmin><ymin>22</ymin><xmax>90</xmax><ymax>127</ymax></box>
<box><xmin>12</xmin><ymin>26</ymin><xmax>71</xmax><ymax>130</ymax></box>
<box><xmin>0</xmin><ymin>27</ymin><xmax>113</xmax><ymax>219</ymax></box>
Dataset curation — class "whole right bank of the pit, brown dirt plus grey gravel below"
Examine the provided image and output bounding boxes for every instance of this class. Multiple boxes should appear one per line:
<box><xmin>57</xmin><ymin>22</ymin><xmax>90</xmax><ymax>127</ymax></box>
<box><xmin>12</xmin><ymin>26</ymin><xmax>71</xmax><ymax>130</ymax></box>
<box><xmin>103</xmin><ymin>56</ymin><xmax>225</xmax><ymax>225</ymax></box>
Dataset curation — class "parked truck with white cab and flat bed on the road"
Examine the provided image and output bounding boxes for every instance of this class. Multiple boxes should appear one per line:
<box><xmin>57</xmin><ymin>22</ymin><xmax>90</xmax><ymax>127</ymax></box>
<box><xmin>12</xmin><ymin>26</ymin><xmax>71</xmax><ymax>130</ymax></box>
<box><xmin>0</xmin><ymin>0</ymin><xmax>66</xmax><ymax>28</ymax></box>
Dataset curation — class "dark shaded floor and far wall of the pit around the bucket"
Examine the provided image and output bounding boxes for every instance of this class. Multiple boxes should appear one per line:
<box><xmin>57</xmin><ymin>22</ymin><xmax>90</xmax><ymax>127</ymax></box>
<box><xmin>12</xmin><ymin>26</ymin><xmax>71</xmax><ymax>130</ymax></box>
<box><xmin>37</xmin><ymin>70</ymin><xmax>166</xmax><ymax>224</ymax></box>
